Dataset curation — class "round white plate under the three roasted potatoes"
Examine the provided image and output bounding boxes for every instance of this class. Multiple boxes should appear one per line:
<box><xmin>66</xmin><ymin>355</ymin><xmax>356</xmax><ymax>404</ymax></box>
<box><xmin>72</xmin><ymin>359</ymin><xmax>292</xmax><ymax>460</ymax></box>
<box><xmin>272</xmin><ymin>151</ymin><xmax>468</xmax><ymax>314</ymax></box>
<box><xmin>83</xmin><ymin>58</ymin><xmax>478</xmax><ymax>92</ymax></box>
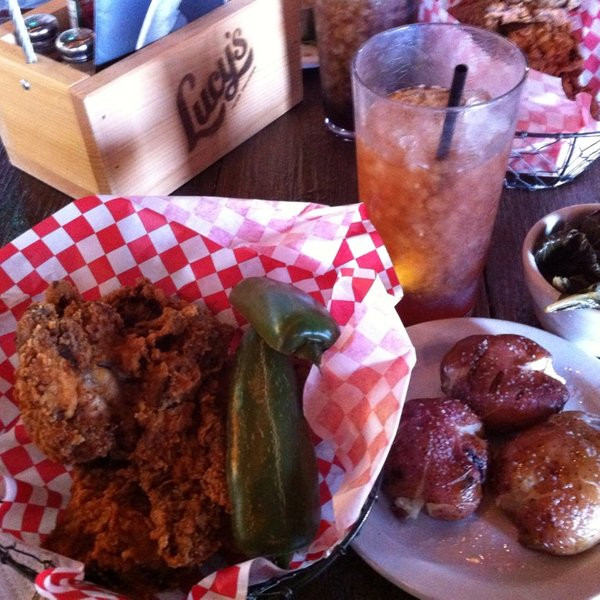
<box><xmin>352</xmin><ymin>319</ymin><xmax>600</xmax><ymax>600</ymax></box>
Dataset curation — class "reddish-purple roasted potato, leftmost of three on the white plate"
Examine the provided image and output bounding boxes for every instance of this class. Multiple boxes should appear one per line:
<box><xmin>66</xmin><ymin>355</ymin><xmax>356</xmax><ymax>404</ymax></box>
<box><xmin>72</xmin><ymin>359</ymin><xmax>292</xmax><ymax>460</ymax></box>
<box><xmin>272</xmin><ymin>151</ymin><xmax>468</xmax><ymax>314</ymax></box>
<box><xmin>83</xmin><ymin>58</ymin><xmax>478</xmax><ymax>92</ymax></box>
<box><xmin>383</xmin><ymin>398</ymin><xmax>488</xmax><ymax>521</ymax></box>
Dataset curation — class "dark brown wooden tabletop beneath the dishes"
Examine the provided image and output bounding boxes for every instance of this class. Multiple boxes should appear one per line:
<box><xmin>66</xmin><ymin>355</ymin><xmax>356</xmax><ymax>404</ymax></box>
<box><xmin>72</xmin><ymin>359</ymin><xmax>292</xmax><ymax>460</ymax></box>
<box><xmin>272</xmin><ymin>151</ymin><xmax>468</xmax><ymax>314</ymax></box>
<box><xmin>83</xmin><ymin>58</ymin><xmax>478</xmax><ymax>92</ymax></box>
<box><xmin>0</xmin><ymin>70</ymin><xmax>600</xmax><ymax>600</ymax></box>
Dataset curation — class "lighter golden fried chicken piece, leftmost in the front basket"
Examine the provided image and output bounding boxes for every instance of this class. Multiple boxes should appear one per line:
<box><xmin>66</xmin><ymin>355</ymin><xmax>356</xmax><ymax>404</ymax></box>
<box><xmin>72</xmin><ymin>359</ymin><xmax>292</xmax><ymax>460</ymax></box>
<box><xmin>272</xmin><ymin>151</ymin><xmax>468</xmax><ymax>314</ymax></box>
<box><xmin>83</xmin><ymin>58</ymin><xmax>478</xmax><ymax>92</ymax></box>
<box><xmin>15</xmin><ymin>281</ymin><xmax>122</xmax><ymax>464</ymax></box>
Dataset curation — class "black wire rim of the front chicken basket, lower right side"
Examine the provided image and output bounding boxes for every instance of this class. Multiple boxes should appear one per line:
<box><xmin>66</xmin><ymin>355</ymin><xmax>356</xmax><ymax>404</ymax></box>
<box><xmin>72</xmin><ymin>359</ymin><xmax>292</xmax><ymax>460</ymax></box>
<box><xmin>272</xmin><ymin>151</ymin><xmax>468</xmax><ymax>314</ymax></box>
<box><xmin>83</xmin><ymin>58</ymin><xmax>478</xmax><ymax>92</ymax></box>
<box><xmin>246</xmin><ymin>476</ymin><xmax>381</xmax><ymax>600</ymax></box>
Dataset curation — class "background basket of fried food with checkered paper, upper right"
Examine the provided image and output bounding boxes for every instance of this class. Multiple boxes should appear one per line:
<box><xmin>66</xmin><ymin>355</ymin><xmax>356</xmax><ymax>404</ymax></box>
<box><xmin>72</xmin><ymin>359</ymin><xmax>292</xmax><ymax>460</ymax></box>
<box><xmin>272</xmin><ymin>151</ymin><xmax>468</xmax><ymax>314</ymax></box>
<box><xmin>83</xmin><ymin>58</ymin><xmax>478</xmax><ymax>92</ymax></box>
<box><xmin>419</xmin><ymin>0</ymin><xmax>600</xmax><ymax>190</ymax></box>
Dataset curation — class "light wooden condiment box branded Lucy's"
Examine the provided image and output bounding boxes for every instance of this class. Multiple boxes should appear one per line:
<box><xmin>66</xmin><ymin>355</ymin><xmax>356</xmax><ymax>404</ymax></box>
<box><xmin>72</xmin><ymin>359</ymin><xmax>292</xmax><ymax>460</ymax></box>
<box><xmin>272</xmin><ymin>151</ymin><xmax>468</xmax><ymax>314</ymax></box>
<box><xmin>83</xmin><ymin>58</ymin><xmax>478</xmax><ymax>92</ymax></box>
<box><xmin>0</xmin><ymin>0</ymin><xmax>302</xmax><ymax>197</ymax></box>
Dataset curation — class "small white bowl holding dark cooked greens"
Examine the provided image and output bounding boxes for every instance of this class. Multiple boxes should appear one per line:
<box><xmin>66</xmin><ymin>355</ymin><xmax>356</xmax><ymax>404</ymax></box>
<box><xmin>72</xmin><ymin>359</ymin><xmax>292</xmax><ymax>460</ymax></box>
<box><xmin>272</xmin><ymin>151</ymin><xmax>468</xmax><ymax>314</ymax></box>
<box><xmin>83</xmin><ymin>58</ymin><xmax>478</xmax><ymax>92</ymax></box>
<box><xmin>521</xmin><ymin>204</ymin><xmax>600</xmax><ymax>356</ymax></box>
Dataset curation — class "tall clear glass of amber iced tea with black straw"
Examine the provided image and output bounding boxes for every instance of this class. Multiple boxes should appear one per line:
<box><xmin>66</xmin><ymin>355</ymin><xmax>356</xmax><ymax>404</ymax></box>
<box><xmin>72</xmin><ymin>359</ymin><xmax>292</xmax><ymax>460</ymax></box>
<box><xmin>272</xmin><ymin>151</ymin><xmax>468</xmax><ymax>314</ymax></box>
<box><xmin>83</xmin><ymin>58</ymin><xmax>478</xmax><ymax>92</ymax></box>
<box><xmin>352</xmin><ymin>23</ymin><xmax>527</xmax><ymax>325</ymax></box>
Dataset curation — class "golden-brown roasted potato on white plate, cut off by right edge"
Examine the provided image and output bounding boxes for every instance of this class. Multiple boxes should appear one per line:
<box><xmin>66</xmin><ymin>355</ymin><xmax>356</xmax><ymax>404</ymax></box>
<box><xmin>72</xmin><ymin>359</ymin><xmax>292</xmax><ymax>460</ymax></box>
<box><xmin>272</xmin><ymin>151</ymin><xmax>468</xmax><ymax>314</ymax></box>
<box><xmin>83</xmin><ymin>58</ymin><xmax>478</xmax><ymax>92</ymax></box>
<box><xmin>494</xmin><ymin>411</ymin><xmax>600</xmax><ymax>555</ymax></box>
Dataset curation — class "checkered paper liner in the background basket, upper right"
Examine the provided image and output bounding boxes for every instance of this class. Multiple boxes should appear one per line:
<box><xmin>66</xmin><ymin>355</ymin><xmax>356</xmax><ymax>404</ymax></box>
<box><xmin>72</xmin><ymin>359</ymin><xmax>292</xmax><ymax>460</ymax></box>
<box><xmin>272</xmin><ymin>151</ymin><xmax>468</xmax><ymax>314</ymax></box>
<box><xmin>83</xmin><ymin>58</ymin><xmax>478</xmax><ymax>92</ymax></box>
<box><xmin>418</xmin><ymin>0</ymin><xmax>600</xmax><ymax>179</ymax></box>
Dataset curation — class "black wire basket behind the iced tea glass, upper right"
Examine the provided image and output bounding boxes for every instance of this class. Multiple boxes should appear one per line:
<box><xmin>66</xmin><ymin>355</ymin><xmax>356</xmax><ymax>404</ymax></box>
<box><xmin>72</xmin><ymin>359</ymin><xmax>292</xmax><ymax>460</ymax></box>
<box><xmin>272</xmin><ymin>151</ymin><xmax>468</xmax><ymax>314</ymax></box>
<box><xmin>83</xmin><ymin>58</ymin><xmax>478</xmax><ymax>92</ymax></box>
<box><xmin>504</xmin><ymin>131</ymin><xmax>600</xmax><ymax>190</ymax></box>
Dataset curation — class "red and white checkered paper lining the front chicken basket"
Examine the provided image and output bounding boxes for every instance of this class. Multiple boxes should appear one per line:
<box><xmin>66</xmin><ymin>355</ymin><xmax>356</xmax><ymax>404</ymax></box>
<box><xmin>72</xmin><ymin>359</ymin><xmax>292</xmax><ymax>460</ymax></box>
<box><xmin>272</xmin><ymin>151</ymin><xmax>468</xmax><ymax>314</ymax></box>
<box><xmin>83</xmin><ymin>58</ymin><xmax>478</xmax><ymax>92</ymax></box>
<box><xmin>0</xmin><ymin>196</ymin><xmax>415</xmax><ymax>600</ymax></box>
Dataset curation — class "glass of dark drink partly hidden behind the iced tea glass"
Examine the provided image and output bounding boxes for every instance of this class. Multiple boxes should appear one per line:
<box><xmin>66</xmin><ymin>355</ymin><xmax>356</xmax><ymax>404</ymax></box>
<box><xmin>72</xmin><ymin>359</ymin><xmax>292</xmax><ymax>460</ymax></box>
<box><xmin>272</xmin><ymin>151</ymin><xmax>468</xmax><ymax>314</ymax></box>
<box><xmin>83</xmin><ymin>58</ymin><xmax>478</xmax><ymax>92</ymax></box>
<box><xmin>313</xmin><ymin>0</ymin><xmax>417</xmax><ymax>139</ymax></box>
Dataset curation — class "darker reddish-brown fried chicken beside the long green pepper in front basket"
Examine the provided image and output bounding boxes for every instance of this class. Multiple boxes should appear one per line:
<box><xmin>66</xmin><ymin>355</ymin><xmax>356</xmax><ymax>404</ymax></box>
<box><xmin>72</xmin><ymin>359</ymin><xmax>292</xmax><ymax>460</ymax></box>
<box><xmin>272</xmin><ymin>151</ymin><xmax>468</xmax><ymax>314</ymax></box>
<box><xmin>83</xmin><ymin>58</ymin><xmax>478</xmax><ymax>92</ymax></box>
<box><xmin>28</xmin><ymin>281</ymin><xmax>233</xmax><ymax>584</ymax></box>
